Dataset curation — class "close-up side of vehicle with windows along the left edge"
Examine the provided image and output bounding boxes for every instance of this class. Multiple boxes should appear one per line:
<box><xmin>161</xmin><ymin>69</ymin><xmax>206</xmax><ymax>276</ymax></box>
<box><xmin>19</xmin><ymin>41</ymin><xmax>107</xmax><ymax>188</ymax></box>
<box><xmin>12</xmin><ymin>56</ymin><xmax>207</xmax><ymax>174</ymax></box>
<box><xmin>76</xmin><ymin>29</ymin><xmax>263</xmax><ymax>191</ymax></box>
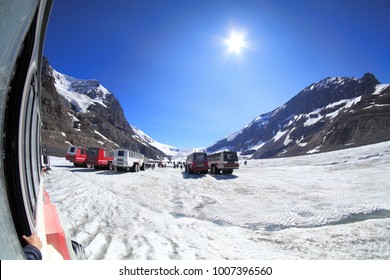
<box><xmin>0</xmin><ymin>0</ymin><xmax>85</xmax><ymax>260</ymax></box>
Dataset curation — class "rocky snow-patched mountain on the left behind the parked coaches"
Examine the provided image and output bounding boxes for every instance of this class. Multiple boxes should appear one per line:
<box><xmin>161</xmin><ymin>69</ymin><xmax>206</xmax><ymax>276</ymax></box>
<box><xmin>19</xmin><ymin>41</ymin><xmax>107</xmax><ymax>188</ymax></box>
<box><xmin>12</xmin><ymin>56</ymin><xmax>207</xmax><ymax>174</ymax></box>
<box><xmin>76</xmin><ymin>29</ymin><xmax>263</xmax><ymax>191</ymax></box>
<box><xmin>42</xmin><ymin>59</ymin><xmax>166</xmax><ymax>159</ymax></box>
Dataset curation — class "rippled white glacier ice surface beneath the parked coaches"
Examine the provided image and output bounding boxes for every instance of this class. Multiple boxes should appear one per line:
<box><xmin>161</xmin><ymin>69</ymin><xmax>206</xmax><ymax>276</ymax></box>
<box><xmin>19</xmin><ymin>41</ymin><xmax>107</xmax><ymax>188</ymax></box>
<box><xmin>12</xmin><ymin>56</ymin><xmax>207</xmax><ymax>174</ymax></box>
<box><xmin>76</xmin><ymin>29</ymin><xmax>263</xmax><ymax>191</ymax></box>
<box><xmin>44</xmin><ymin>142</ymin><xmax>390</xmax><ymax>260</ymax></box>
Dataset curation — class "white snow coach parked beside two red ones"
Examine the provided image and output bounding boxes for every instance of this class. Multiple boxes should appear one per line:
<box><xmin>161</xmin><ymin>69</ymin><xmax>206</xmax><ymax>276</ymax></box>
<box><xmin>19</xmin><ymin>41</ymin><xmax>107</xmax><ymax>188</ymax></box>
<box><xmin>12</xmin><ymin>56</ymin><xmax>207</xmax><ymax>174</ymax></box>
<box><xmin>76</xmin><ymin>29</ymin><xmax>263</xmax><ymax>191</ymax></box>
<box><xmin>113</xmin><ymin>149</ymin><xmax>145</xmax><ymax>172</ymax></box>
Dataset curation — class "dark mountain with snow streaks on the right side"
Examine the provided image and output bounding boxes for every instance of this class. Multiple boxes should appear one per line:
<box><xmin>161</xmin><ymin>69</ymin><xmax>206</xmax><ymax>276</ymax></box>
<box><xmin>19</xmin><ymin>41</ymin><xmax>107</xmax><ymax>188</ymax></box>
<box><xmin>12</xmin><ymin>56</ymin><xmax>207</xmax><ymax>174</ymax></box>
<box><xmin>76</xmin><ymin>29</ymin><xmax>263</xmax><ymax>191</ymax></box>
<box><xmin>207</xmin><ymin>73</ymin><xmax>390</xmax><ymax>158</ymax></box>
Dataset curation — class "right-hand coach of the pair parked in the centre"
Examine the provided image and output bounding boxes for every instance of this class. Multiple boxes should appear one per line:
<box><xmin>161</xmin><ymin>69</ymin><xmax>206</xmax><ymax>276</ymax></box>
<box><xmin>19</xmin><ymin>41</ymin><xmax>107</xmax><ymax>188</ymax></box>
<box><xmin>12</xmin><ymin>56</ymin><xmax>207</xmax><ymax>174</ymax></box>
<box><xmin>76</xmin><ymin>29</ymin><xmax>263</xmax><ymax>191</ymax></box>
<box><xmin>207</xmin><ymin>151</ymin><xmax>240</xmax><ymax>174</ymax></box>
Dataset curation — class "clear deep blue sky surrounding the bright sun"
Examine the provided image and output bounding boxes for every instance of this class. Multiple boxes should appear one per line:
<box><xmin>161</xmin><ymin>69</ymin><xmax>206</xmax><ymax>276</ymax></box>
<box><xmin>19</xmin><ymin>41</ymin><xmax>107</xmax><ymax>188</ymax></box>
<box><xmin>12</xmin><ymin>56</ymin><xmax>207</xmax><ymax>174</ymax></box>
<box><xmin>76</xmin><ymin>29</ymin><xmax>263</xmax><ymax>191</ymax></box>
<box><xmin>44</xmin><ymin>0</ymin><xmax>390</xmax><ymax>148</ymax></box>
